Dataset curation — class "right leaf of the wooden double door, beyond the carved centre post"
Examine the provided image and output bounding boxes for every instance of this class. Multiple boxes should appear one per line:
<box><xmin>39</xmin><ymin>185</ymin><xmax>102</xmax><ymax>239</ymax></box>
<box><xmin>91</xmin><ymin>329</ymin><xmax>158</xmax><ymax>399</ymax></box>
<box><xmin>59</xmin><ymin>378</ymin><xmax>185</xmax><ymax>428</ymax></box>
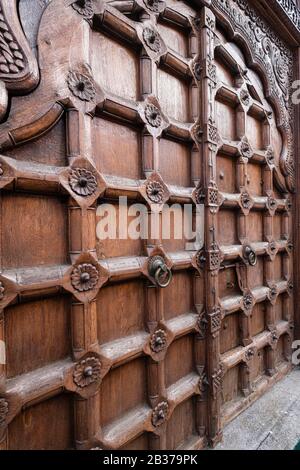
<box><xmin>216</xmin><ymin>3</ymin><xmax>293</xmax><ymax>432</ymax></box>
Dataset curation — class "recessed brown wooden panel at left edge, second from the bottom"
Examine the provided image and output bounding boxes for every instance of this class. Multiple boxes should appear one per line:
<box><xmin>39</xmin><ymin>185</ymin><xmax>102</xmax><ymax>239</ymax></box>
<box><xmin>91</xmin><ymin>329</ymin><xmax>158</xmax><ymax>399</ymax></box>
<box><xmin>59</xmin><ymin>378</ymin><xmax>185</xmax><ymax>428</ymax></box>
<box><xmin>5</xmin><ymin>296</ymin><xmax>71</xmax><ymax>377</ymax></box>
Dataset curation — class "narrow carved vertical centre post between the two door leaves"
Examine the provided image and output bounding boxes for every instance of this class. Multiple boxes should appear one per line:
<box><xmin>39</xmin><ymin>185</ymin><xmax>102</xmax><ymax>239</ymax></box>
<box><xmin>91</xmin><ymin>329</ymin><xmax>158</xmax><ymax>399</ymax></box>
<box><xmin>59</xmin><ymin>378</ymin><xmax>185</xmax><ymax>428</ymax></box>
<box><xmin>199</xmin><ymin>7</ymin><xmax>222</xmax><ymax>445</ymax></box>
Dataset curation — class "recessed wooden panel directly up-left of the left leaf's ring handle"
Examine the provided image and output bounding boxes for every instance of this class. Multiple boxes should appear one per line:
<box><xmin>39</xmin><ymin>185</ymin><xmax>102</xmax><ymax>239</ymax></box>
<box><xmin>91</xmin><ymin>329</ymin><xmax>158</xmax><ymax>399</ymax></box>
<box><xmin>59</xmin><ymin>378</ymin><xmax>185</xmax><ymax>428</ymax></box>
<box><xmin>96</xmin><ymin>200</ymin><xmax>147</xmax><ymax>259</ymax></box>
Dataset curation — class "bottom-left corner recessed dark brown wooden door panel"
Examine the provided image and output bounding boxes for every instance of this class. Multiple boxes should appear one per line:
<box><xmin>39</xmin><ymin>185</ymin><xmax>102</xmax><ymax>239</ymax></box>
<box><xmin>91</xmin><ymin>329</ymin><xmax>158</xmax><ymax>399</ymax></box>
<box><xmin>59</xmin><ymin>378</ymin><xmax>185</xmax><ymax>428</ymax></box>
<box><xmin>8</xmin><ymin>395</ymin><xmax>74</xmax><ymax>450</ymax></box>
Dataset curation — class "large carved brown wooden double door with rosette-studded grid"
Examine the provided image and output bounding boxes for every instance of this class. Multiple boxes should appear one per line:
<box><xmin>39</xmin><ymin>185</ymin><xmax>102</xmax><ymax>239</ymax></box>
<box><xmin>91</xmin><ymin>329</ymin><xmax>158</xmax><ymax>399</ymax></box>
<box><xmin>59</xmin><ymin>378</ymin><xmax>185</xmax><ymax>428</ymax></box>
<box><xmin>0</xmin><ymin>0</ymin><xmax>294</xmax><ymax>450</ymax></box>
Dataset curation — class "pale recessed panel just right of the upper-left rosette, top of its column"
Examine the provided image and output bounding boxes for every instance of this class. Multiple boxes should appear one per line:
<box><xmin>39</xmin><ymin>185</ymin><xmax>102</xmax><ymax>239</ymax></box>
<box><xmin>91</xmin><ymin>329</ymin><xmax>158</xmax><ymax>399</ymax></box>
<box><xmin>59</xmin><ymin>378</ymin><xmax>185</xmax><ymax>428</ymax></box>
<box><xmin>91</xmin><ymin>31</ymin><xmax>139</xmax><ymax>100</ymax></box>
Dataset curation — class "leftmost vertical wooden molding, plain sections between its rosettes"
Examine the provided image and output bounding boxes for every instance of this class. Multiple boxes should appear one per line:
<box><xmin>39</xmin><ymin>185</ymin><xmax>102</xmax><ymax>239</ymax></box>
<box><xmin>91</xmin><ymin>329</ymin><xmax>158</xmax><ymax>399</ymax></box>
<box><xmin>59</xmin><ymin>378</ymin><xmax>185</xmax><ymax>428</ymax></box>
<box><xmin>67</xmin><ymin>109</ymin><xmax>100</xmax><ymax>449</ymax></box>
